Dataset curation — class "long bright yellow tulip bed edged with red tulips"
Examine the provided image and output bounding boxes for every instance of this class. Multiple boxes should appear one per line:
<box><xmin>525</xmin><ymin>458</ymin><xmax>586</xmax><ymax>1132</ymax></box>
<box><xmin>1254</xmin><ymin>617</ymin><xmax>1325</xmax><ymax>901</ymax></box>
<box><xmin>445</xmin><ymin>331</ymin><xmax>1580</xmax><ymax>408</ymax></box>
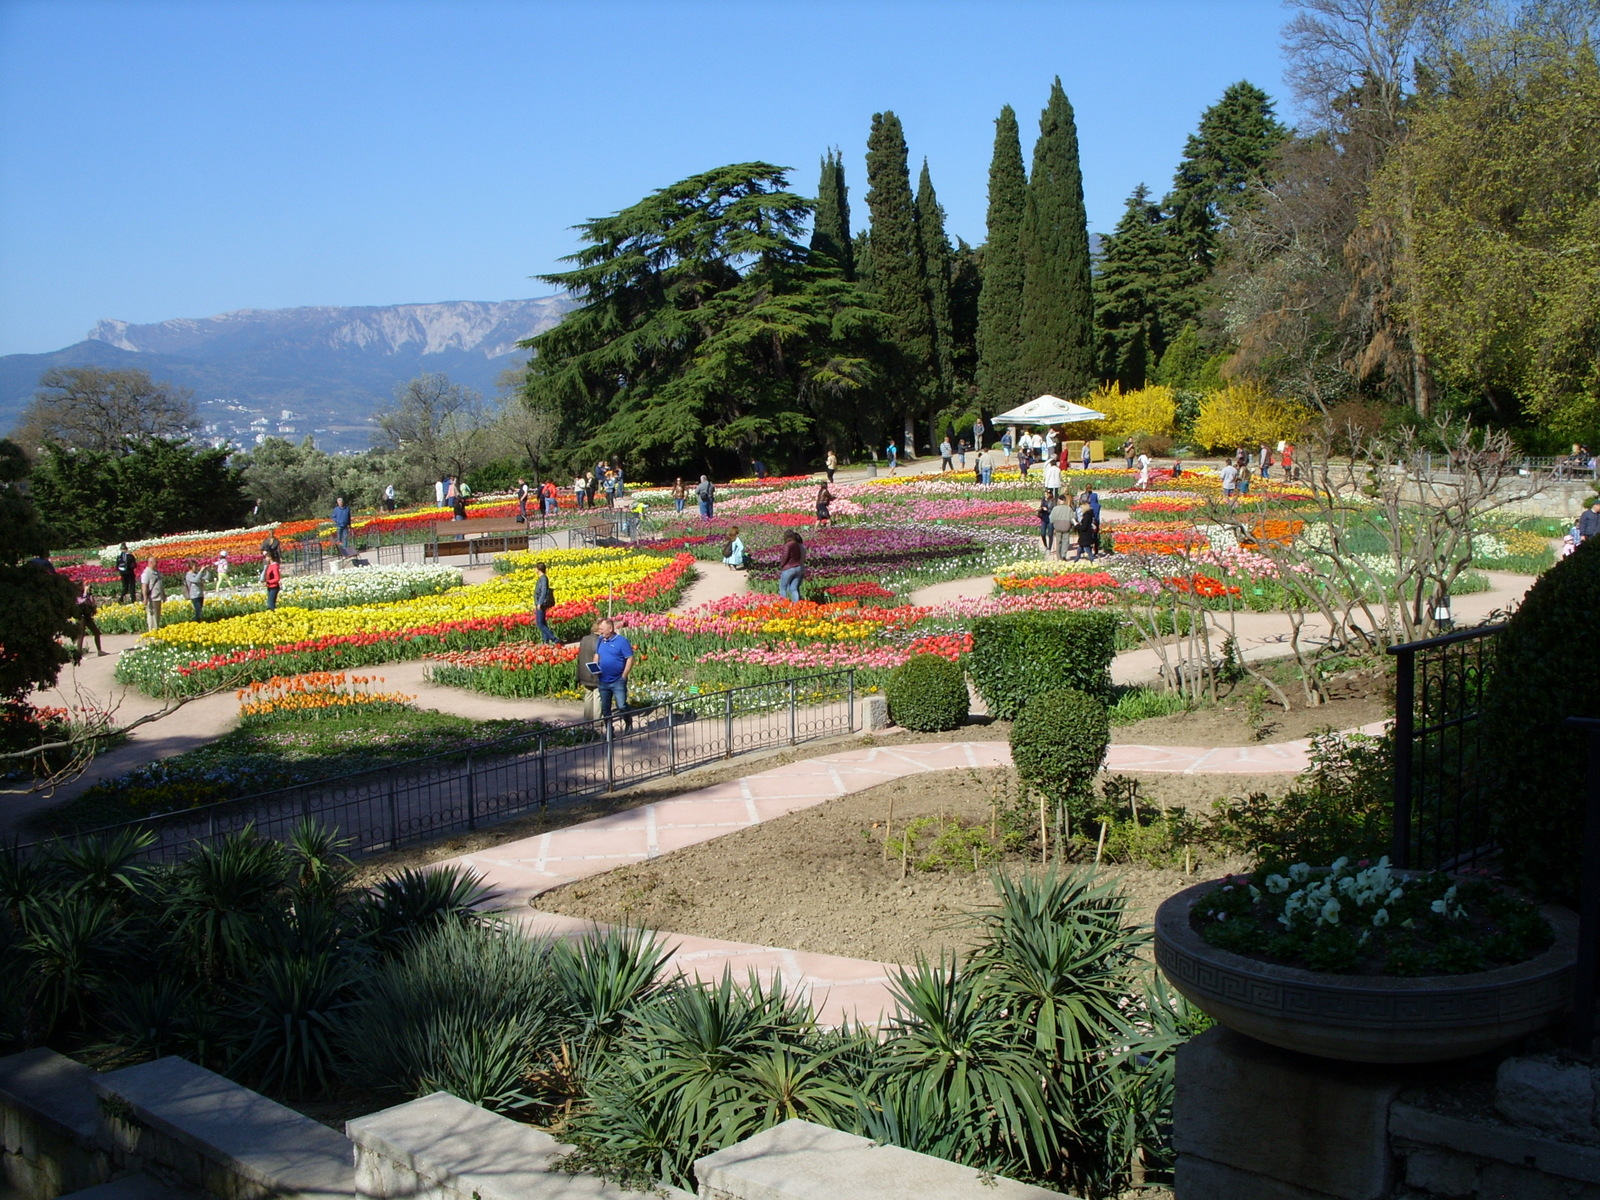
<box><xmin>117</xmin><ymin>549</ymin><xmax>694</xmax><ymax>696</ymax></box>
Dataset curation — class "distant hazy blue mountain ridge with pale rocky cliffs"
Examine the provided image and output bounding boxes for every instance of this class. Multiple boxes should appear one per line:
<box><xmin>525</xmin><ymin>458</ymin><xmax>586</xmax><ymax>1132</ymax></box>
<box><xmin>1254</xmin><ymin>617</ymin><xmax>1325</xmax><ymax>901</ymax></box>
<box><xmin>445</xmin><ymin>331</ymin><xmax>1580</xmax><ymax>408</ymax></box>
<box><xmin>0</xmin><ymin>296</ymin><xmax>574</xmax><ymax>450</ymax></box>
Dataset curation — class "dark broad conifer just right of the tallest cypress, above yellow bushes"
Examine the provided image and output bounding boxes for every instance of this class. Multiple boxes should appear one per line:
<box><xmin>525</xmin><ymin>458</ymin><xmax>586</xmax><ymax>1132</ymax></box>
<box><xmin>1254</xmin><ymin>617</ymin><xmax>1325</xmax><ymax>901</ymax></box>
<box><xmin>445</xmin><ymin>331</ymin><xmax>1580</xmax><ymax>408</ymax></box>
<box><xmin>1094</xmin><ymin>184</ymin><xmax>1184</xmax><ymax>389</ymax></box>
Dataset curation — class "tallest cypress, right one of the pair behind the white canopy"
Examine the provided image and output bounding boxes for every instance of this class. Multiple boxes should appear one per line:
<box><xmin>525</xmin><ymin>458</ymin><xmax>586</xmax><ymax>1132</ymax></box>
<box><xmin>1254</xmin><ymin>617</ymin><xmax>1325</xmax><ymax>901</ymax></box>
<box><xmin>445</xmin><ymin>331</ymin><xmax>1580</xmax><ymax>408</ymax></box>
<box><xmin>1022</xmin><ymin>78</ymin><xmax>1094</xmax><ymax>397</ymax></box>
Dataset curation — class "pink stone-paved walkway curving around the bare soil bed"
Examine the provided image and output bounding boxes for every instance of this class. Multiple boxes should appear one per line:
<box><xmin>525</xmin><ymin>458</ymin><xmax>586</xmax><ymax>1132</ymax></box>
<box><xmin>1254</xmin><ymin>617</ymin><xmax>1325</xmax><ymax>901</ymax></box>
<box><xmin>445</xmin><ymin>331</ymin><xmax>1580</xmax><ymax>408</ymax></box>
<box><xmin>451</xmin><ymin>726</ymin><xmax>1381</xmax><ymax>1024</ymax></box>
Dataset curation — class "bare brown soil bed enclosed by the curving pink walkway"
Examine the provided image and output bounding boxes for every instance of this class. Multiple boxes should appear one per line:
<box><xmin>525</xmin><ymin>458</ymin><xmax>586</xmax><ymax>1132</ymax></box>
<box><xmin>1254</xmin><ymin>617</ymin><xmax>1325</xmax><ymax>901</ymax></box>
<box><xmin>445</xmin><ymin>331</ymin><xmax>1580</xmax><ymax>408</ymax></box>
<box><xmin>534</xmin><ymin>770</ymin><xmax>1273</xmax><ymax>963</ymax></box>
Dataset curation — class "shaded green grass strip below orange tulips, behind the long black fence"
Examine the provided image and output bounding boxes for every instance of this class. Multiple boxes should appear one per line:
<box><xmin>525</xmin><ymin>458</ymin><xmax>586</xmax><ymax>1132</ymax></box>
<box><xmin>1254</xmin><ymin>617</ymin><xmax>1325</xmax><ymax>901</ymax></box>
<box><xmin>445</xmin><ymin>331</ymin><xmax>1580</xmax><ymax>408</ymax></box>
<box><xmin>29</xmin><ymin>704</ymin><xmax>539</xmax><ymax>832</ymax></box>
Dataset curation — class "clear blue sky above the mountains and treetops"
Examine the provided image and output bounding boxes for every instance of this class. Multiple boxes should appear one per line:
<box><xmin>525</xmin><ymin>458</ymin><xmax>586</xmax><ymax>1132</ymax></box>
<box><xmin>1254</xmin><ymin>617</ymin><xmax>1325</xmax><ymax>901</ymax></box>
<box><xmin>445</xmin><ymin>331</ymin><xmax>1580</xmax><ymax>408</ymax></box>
<box><xmin>0</xmin><ymin>0</ymin><xmax>1294</xmax><ymax>354</ymax></box>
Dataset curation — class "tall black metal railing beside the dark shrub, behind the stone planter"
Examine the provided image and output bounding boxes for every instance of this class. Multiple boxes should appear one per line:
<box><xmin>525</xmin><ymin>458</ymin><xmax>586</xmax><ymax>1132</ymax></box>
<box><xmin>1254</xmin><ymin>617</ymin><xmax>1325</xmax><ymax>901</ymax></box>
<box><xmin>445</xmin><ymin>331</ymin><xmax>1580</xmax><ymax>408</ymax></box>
<box><xmin>1389</xmin><ymin>626</ymin><xmax>1504</xmax><ymax>870</ymax></box>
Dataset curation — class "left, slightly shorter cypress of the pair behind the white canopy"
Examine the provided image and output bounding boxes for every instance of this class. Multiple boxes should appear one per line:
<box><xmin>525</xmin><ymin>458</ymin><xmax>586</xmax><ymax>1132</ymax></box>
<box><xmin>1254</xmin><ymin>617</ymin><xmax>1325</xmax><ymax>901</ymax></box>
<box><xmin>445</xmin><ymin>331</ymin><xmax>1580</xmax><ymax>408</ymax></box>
<box><xmin>978</xmin><ymin>104</ymin><xmax>1030</xmax><ymax>414</ymax></box>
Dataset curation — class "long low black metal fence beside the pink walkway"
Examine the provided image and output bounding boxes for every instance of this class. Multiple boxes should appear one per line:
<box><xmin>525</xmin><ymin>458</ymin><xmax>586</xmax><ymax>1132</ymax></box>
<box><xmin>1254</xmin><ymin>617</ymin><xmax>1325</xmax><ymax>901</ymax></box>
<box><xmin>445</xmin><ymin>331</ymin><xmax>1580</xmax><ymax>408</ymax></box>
<box><xmin>24</xmin><ymin>670</ymin><xmax>856</xmax><ymax>862</ymax></box>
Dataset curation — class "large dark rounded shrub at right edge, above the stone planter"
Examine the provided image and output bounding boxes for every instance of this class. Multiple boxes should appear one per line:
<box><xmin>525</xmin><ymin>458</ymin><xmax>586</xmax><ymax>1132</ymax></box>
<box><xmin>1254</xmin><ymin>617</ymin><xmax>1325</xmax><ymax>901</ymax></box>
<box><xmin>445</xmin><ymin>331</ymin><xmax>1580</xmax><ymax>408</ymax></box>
<box><xmin>1478</xmin><ymin>541</ymin><xmax>1600</xmax><ymax>904</ymax></box>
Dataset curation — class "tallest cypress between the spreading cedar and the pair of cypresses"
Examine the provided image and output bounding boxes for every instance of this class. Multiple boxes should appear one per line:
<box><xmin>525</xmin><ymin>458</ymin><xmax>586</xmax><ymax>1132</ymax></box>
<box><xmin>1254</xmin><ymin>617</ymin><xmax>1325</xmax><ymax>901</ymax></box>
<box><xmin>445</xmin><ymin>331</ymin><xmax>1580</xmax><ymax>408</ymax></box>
<box><xmin>867</xmin><ymin>112</ymin><xmax>938</xmax><ymax>438</ymax></box>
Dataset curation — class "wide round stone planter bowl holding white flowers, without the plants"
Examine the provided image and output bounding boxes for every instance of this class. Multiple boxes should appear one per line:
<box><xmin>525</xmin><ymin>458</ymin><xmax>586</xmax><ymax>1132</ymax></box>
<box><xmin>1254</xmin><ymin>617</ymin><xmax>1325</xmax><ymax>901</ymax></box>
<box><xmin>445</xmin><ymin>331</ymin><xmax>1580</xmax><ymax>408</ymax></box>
<box><xmin>1155</xmin><ymin>880</ymin><xmax>1578</xmax><ymax>1062</ymax></box>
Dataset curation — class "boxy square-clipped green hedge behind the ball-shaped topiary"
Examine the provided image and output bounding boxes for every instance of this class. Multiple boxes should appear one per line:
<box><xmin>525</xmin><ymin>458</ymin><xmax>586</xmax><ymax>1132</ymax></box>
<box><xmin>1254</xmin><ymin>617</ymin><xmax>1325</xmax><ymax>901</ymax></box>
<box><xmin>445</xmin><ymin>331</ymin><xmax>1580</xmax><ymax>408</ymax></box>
<box><xmin>968</xmin><ymin>613</ymin><xmax>1117</xmax><ymax>720</ymax></box>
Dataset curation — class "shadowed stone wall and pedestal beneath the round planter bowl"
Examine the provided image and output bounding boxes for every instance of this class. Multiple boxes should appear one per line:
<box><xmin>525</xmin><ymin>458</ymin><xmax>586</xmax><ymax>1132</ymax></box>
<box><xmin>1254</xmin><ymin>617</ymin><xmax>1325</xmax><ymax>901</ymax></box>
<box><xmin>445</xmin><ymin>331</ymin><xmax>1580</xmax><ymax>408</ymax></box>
<box><xmin>1173</xmin><ymin>1029</ymin><xmax>1600</xmax><ymax>1200</ymax></box>
